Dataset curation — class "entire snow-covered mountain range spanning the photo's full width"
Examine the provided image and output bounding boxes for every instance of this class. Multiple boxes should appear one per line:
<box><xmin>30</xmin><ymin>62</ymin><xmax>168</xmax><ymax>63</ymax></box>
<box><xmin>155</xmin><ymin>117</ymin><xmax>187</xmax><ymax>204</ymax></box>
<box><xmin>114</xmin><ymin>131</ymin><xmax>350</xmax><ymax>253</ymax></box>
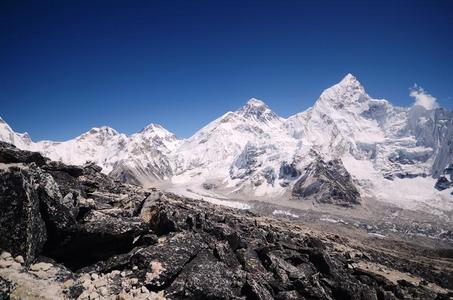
<box><xmin>0</xmin><ymin>74</ymin><xmax>453</xmax><ymax>212</ymax></box>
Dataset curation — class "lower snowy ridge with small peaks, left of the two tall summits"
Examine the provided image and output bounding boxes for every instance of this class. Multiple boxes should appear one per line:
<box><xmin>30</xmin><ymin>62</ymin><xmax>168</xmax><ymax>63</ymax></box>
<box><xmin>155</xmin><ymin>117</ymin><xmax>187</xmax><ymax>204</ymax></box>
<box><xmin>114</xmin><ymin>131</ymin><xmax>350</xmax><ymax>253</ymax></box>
<box><xmin>0</xmin><ymin>120</ymin><xmax>180</xmax><ymax>185</ymax></box>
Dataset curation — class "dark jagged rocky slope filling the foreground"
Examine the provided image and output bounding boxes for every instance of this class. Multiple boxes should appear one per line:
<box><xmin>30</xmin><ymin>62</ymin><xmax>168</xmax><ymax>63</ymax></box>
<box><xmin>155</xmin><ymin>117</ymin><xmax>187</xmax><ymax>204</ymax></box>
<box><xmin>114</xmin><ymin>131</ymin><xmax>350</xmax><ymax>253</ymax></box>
<box><xmin>0</xmin><ymin>143</ymin><xmax>453</xmax><ymax>299</ymax></box>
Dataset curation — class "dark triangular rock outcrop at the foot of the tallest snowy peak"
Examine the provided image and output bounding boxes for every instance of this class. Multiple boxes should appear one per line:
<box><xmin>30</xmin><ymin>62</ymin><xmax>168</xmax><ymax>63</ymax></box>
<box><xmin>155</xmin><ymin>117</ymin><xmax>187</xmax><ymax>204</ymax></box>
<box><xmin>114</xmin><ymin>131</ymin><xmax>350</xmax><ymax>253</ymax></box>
<box><xmin>292</xmin><ymin>158</ymin><xmax>360</xmax><ymax>206</ymax></box>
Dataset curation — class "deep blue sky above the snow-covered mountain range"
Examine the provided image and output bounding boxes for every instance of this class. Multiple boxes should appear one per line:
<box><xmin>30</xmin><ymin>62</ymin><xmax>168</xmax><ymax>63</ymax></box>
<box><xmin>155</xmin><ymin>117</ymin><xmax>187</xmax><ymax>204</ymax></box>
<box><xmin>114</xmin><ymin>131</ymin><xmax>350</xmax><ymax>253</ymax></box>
<box><xmin>0</xmin><ymin>0</ymin><xmax>453</xmax><ymax>140</ymax></box>
